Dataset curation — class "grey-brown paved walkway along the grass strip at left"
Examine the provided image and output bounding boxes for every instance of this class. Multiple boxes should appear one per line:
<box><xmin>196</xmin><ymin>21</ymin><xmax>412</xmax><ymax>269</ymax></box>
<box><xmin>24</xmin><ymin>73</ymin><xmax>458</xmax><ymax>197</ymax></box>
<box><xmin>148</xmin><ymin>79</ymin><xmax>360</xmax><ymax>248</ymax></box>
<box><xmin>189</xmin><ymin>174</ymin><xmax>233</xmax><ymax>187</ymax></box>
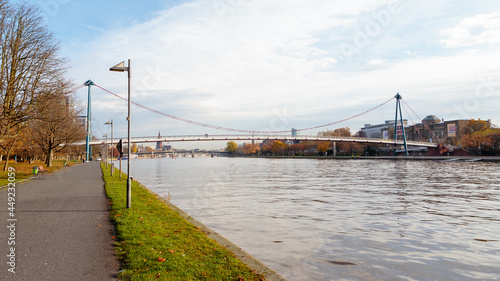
<box><xmin>0</xmin><ymin>162</ymin><xmax>119</xmax><ymax>281</ymax></box>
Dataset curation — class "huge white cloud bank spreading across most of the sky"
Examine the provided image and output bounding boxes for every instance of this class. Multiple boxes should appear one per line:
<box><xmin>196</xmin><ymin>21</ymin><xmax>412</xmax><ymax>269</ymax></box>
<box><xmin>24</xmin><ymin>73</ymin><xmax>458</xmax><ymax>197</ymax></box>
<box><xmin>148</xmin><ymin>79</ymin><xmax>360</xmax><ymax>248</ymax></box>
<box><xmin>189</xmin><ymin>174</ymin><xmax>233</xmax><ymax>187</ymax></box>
<box><xmin>67</xmin><ymin>0</ymin><xmax>500</xmax><ymax>144</ymax></box>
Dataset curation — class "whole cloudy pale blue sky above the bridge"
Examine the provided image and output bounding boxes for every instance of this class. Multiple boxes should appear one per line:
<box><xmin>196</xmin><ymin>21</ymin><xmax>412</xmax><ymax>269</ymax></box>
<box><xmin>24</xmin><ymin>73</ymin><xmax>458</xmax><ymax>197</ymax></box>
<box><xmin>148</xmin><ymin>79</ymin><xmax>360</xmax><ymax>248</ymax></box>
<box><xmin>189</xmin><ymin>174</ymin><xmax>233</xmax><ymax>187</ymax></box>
<box><xmin>26</xmin><ymin>0</ymin><xmax>500</xmax><ymax>148</ymax></box>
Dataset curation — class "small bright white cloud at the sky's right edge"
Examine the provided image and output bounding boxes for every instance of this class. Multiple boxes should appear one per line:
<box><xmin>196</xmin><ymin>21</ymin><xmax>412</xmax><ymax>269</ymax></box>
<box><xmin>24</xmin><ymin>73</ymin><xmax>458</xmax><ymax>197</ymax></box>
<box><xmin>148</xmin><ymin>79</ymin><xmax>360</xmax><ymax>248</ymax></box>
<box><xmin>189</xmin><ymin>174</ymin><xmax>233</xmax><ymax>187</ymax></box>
<box><xmin>440</xmin><ymin>12</ymin><xmax>500</xmax><ymax>48</ymax></box>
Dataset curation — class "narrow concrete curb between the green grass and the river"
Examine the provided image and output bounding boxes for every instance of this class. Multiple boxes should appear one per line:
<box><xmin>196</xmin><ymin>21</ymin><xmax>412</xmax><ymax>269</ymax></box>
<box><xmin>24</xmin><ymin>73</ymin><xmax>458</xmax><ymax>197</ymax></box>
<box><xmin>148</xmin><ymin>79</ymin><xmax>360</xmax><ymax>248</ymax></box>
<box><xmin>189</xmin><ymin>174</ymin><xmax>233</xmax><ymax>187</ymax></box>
<box><xmin>134</xmin><ymin>180</ymin><xmax>287</xmax><ymax>281</ymax></box>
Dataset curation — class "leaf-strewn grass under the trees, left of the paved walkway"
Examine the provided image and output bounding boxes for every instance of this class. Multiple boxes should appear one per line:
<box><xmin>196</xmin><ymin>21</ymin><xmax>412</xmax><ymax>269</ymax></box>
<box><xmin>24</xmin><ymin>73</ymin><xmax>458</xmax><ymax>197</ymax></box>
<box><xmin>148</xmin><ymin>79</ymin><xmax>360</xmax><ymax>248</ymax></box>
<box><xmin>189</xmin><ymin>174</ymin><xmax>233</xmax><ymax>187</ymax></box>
<box><xmin>0</xmin><ymin>160</ymin><xmax>75</xmax><ymax>187</ymax></box>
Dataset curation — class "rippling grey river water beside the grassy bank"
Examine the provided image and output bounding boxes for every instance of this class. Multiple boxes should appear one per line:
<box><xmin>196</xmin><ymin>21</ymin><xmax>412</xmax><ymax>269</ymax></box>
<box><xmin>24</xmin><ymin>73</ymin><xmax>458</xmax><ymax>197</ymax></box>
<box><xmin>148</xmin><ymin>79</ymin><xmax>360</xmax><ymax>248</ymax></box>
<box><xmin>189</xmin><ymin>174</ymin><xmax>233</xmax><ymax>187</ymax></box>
<box><xmin>131</xmin><ymin>157</ymin><xmax>500</xmax><ymax>280</ymax></box>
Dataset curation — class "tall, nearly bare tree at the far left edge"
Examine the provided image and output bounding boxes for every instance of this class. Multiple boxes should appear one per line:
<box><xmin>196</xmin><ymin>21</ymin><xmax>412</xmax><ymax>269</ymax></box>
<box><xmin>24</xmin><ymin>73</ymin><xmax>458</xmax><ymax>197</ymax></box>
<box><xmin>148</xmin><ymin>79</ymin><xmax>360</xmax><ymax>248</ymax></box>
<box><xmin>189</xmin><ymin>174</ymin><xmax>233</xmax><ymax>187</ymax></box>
<box><xmin>0</xmin><ymin>0</ymin><xmax>65</xmax><ymax>169</ymax></box>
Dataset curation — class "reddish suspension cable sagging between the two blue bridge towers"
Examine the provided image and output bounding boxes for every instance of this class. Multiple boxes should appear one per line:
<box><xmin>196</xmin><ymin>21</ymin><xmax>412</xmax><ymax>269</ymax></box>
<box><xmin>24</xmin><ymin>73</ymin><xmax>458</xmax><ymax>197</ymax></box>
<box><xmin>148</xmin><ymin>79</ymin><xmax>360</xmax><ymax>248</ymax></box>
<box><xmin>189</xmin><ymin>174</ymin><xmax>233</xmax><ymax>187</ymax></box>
<box><xmin>94</xmin><ymin>84</ymin><xmax>395</xmax><ymax>134</ymax></box>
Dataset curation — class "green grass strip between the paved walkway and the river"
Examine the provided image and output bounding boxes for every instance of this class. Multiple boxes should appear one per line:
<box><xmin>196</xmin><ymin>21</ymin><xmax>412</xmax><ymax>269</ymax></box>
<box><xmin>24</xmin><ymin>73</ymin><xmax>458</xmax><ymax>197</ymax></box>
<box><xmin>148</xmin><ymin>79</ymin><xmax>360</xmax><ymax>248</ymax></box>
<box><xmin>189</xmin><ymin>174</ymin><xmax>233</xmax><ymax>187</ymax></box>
<box><xmin>101</xmin><ymin>163</ymin><xmax>263</xmax><ymax>280</ymax></box>
